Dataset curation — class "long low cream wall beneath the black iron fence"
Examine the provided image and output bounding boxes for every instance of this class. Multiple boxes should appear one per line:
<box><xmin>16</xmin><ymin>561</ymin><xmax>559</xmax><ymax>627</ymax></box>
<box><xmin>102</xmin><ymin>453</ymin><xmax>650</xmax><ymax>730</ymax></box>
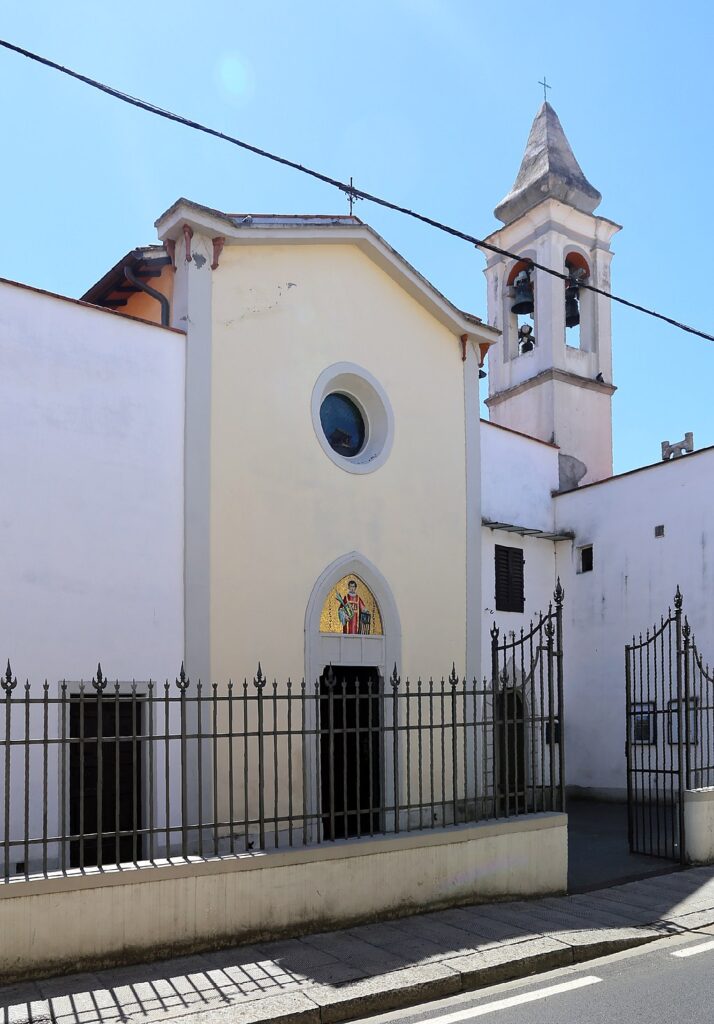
<box><xmin>0</xmin><ymin>814</ymin><xmax>568</xmax><ymax>983</ymax></box>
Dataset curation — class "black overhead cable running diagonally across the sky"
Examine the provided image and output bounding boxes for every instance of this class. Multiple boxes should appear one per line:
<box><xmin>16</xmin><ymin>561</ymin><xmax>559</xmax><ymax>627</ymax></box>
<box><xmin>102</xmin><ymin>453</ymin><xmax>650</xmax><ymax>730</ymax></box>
<box><xmin>0</xmin><ymin>39</ymin><xmax>714</xmax><ymax>341</ymax></box>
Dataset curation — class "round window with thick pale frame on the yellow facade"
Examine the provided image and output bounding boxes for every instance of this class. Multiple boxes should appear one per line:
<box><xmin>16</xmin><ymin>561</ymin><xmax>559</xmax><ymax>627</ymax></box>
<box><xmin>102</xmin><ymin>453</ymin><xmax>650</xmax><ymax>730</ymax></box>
<box><xmin>310</xmin><ymin>362</ymin><xmax>394</xmax><ymax>473</ymax></box>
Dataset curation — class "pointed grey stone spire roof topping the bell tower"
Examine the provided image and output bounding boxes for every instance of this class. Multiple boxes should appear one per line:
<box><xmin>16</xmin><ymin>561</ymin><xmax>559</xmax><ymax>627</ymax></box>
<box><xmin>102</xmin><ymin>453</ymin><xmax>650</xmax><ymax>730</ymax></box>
<box><xmin>494</xmin><ymin>102</ymin><xmax>602</xmax><ymax>224</ymax></box>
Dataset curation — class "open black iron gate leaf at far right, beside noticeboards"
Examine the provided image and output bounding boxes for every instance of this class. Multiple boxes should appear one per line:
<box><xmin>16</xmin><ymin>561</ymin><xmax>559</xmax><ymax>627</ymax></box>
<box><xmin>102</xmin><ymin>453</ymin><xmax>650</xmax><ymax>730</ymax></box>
<box><xmin>625</xmin><ymin>587</ymin><xmax>714</xmax><ymax>863</ymax></box>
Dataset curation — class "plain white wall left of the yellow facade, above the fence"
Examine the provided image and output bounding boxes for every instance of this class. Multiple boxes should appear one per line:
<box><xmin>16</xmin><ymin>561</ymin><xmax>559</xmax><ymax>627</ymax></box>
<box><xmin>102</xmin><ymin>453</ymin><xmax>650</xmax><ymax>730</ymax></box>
<box><xmin>0</xmin><ymin>282</ymin><xmax>184</xmax><ymax>684</ymax></box>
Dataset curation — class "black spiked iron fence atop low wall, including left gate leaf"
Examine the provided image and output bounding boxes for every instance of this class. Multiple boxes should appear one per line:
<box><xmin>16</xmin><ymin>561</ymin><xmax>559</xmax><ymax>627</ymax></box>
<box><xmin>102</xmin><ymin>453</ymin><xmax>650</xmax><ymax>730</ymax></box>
<box><xmin>0</xmin><ymin>586</ymin><xmax>563</xmax><ymax>882</ymax></box>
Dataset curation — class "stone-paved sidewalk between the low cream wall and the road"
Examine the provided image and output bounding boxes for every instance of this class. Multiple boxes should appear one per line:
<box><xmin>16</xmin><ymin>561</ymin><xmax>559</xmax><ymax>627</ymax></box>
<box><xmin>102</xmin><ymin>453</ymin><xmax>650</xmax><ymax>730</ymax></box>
<box><xmin>0</xmin><ymin>867</ymin><xmax>714</xmax><ymax>1024</ymax></box>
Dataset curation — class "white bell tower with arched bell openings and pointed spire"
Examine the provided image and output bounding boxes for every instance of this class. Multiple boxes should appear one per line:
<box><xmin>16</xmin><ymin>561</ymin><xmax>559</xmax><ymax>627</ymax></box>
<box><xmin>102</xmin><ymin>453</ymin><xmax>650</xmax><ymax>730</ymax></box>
<box><xmin>484</xmin><ymin>102</ymin><xmax>620</xmax><ymax>489</ymax></box>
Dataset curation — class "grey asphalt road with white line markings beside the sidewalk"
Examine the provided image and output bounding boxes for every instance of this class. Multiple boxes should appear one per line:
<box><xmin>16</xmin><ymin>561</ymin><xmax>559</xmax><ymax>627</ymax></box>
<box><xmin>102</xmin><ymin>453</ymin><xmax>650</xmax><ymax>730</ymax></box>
<box><xmin>364</xmin><ymin>928</ymin><xmax>714</xmax><ymax>1024</ymax></box>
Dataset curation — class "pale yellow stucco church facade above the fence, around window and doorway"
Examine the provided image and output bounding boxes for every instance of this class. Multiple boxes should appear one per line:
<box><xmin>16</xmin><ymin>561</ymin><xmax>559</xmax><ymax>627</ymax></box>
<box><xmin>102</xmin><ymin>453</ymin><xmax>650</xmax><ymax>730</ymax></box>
<box><xmin>210</xmin><ymin>245</ymin><xmax>466</xmax><ymax>680</ymax></box>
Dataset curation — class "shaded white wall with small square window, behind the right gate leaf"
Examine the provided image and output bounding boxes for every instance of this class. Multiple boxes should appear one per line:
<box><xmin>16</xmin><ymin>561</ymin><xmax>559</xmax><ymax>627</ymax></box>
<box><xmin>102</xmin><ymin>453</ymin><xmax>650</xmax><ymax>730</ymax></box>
<box><xmin>554</xmin><ymin>449</ymin><xmax>714</xmax><ymax>798</ymax></box>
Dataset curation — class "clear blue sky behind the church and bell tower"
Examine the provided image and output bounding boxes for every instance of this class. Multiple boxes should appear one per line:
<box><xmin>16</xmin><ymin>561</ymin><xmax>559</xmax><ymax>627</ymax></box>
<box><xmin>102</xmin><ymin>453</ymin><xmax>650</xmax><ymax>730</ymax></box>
<box><xmin>0</xmin><ymin>0</ymin><xmax>714</xmax><ymax>471</ymax></box>
